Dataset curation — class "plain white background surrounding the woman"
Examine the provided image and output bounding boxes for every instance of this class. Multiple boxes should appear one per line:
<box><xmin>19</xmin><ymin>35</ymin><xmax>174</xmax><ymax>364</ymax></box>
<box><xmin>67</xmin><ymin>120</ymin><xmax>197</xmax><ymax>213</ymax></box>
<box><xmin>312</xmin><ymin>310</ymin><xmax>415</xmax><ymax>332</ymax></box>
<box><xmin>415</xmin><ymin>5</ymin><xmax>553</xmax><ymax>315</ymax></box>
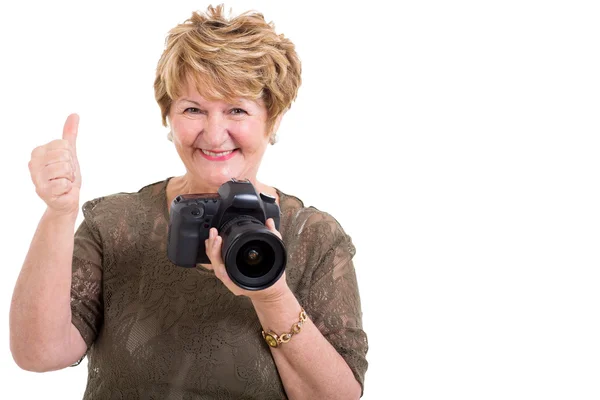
<box><xmin>0</xmin><ymin>0</ymin><xmax>600</xmax><ymax>400</ymax></box>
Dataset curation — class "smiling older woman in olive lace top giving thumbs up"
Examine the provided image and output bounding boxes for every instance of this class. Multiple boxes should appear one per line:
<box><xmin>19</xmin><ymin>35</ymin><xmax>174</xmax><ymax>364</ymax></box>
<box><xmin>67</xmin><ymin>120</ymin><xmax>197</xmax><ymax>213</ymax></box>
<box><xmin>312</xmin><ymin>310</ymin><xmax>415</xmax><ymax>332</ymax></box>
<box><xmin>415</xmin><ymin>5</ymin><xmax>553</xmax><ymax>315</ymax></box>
<box><xmin>10</xmin><ymin>6</ymin><xmax>367</xmax><ymax>400</ymax></box>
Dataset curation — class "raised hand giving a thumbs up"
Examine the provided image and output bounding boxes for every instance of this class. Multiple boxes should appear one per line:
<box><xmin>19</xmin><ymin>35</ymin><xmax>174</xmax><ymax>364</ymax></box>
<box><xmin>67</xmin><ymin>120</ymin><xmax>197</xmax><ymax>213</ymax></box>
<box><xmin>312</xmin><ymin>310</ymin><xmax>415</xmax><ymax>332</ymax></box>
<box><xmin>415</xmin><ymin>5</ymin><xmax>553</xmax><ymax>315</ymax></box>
<box><xmin>29</xmin><ymin>114</ymin><xmax>81</xmax><ymax>215</ymax></box>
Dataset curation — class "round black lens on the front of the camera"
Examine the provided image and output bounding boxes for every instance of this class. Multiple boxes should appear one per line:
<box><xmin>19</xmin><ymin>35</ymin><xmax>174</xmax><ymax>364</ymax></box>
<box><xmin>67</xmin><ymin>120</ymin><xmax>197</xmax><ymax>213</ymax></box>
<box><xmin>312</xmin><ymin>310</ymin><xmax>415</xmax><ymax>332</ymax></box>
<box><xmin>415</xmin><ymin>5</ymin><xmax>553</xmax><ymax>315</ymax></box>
<box><xmin>219</xmin><ymin>215</ymin><xmax>287</xmax><ymax>290</ymax></box>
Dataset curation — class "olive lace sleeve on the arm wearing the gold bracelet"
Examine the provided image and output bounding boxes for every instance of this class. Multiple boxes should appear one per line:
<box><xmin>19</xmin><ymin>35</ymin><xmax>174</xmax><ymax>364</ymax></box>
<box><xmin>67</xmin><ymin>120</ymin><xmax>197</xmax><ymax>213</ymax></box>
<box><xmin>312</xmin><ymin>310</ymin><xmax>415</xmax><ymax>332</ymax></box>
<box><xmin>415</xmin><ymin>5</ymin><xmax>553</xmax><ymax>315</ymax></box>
<box><xmin>303</xmin><ymin>213</ymin><xmax>368</xmax><ymax>396</ymax></box>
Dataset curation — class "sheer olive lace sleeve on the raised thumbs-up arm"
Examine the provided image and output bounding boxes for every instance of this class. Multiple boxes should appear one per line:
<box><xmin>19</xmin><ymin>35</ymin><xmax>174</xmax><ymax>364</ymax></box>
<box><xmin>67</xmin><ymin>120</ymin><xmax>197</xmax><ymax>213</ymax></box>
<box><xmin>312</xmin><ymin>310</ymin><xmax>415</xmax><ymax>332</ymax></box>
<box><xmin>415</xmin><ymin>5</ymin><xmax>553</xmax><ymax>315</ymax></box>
<box><xmin>71</xmin><ymin>202</ymin><xmax>103</xmax><ymax>349</ymax></box>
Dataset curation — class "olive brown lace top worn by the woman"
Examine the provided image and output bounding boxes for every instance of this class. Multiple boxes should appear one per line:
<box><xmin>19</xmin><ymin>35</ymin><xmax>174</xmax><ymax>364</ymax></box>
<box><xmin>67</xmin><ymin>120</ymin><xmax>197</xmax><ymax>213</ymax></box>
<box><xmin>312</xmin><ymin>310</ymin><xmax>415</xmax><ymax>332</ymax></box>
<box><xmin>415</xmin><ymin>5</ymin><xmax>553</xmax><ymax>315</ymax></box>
<box><xmin>71</xmin><ymin>179</ymin><xmax>368</xmax><ymax>400</ymax></box>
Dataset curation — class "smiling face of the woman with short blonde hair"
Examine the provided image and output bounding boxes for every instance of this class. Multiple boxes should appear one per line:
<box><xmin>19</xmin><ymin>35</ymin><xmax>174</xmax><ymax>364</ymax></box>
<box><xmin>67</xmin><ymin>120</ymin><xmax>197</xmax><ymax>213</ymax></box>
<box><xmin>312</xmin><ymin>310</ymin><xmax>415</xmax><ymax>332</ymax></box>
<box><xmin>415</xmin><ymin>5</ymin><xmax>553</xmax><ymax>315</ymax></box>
<box><xmin>169</xmin><ymin>79</ymin><xmax>278</xmax><ymax>191</ymax></box>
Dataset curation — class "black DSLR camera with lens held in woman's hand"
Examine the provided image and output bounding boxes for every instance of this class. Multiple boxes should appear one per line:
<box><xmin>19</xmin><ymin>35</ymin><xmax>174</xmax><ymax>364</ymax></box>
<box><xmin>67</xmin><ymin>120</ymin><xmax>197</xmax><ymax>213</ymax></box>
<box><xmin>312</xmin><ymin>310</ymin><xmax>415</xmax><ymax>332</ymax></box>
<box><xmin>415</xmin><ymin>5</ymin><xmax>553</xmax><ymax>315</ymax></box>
<box><xmin>167</xmin><ymin>179</ymin><xmax>287</xmax><ymax>290</ymax></box>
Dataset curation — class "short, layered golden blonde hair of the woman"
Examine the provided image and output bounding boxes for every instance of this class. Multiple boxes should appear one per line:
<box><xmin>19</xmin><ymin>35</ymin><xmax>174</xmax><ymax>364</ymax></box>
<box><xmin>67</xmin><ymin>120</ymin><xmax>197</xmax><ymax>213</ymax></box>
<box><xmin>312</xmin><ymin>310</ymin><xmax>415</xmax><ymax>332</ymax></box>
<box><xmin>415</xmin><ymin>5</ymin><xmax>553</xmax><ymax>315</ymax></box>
<box><xmin>154</xmin><ymin>4</ymin><xmax>302</xmax><ymax>139</ymax></box>
